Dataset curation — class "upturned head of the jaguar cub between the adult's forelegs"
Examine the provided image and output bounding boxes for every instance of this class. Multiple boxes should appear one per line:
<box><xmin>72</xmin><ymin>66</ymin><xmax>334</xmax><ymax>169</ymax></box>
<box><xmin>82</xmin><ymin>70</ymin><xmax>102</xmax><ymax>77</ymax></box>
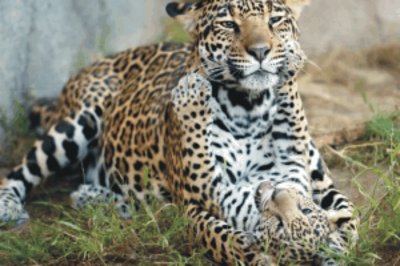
<box><xmin>256</xmin><ymin>182</ymin><xmax>352</xmax><ymax>265</ymax></box>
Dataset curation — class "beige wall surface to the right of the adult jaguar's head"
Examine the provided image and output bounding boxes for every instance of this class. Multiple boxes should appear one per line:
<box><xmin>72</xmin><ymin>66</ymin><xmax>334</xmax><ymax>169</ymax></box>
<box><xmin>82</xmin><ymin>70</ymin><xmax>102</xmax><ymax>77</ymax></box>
<box><xmin>300</xmin><ymin>0</ymin><xmax>400</xmax><ymax>55</ymax></box>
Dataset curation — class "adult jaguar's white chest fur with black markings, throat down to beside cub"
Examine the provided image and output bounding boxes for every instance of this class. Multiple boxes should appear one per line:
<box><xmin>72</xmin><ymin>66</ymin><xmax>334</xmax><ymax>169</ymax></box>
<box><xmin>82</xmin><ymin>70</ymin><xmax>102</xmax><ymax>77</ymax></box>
<box><xmin>207</xmin><ymin>85</ymin><xmax>280</xmax><ymax>231</ymax></box>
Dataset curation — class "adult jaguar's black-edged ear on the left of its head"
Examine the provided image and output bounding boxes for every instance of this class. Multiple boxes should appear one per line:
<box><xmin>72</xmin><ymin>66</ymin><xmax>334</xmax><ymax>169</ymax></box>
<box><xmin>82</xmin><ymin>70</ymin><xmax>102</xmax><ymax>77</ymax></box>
<box><xmin>166</xmin><ymin>1</ymin><xmax>201</xmax><ymax>33</ymax></box>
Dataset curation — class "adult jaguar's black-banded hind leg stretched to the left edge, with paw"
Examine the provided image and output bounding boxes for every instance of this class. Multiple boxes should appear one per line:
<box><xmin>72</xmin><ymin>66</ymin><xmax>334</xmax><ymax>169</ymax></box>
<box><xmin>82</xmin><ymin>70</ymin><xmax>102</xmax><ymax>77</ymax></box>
<box><xmin>0</xmin><ymin>108</ymin><xmax>101</xmax><ymax>222</ymax></box>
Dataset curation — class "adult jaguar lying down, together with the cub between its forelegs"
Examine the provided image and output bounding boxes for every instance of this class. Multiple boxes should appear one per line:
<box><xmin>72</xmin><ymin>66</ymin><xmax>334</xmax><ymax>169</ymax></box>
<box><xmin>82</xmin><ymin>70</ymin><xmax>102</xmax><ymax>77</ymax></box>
<box><xmin>0</xmin><ymin>0</ymin><xmax>357</xmax><ymax>265</ymax></box>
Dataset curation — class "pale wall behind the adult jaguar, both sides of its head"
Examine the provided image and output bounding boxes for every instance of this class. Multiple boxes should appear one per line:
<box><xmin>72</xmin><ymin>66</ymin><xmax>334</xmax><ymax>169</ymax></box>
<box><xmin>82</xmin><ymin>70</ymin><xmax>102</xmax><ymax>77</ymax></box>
<box><xmin>0</xmin><ymin>0</ymin><xmax>400</xmax><ymax>135</ymax></box>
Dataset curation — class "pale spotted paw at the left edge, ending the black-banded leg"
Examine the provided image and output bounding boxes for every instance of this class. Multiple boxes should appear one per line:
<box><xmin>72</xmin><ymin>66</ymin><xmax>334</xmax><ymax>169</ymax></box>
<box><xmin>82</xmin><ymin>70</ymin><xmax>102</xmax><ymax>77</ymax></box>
<box><xmin>0</xmin><ymin>188</ymin><xmax>29</xmax><ymax>225</ymax></box>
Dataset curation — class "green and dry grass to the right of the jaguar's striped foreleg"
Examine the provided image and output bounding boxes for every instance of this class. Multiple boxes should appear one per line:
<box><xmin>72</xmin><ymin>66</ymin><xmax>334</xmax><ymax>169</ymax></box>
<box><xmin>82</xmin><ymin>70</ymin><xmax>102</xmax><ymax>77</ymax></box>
<box><xmin>326</xmin><ymin>113</ymin><xmax>400</xmax><ymax>266</ymax></box>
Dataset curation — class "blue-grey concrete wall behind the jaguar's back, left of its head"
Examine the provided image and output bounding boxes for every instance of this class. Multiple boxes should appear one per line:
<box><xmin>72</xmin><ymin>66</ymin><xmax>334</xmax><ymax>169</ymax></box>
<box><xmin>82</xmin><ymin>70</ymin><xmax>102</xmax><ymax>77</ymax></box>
<box><xmin>0</xmin><ymin>0</ymin><xmax>165</xmax><ymax>120</ymax></box>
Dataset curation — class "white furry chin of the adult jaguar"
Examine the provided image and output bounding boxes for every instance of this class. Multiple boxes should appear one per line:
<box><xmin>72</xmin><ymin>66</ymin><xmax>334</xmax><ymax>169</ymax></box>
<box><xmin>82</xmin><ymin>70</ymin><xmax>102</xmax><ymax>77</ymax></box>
<box><xmin>239</xmin><ymin>72</ymin><xmax>280</xmax><ymax>92</ymax></box>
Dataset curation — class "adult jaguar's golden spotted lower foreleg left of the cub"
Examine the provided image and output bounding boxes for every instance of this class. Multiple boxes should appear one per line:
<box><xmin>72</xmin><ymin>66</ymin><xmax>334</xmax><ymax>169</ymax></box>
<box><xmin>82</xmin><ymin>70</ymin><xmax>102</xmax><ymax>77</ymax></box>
<box><xmin>188</xmin><ymin>205</ymin><xmax>272</xmax><ymax>266</ymax></box>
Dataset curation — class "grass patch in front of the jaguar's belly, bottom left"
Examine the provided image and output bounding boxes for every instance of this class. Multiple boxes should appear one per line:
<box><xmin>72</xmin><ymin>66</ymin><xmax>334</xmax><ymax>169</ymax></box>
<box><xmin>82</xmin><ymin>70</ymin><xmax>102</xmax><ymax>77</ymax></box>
<box><xmin>0</xmin><ymin>194</ymin><xmax>208</xmax><ymax>265</ymax></box>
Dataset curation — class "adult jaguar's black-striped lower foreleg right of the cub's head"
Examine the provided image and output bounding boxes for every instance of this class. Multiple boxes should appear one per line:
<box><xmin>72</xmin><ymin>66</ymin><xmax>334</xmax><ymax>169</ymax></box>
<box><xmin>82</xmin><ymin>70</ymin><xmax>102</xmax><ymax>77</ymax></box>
<box><xmin>309</xmin><ymin>143</ymin><xmax>359</xmax><ymax>265</ymax></box>
